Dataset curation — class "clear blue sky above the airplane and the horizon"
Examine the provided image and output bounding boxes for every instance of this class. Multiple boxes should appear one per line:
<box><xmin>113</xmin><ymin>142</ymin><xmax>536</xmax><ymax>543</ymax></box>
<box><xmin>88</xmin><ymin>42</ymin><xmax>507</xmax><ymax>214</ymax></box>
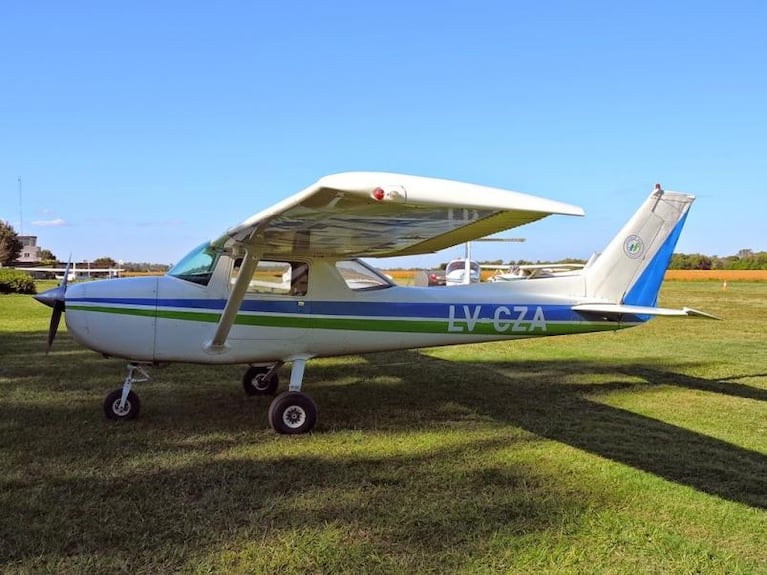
<box><xmin>0</xmin><ymin>0</ymin><xmax>767</xmax><ymax>265</ymax></box>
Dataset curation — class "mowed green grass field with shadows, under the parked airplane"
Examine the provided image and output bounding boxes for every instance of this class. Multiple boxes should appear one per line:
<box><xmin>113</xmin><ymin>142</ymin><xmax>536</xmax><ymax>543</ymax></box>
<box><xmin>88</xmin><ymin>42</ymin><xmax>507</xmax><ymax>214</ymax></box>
<box><xmin>0</xmin><ymin>282</ymin><xmax>767</xmax><ymax>573</ymax></box>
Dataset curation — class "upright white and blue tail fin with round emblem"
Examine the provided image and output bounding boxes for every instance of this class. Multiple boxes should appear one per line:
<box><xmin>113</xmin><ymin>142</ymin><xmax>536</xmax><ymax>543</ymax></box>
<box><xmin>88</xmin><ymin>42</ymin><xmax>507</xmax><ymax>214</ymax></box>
<box><xmin>584</xmin><ymin>185</ymin><xmax>695</xmax><ymax>306</ymax></box>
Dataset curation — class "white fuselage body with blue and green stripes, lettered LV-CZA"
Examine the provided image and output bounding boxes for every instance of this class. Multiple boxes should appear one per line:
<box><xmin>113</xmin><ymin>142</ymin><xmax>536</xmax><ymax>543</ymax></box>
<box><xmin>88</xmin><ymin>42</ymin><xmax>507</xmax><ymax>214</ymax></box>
<box><xmin>66</xmin><ymin>258</ymin><xmax>639</xmax><ymax>363</ymax></box>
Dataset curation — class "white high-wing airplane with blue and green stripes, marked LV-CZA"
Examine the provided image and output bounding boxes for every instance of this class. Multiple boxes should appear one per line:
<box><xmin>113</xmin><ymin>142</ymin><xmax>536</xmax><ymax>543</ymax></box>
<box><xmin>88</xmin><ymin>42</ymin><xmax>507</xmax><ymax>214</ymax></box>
<box><xmin>35</xmin><ymin>172</ymin><xmax>714</xmax><ymax>434</ymax></box>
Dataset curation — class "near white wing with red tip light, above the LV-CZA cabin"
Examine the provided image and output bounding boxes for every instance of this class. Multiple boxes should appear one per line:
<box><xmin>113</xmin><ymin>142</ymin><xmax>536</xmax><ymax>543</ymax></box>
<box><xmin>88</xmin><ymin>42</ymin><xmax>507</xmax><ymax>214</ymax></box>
<box><xmin>215</xmin><ymin>172</ymin><xmax>583</xmax><ymax>259</ymax></box>
